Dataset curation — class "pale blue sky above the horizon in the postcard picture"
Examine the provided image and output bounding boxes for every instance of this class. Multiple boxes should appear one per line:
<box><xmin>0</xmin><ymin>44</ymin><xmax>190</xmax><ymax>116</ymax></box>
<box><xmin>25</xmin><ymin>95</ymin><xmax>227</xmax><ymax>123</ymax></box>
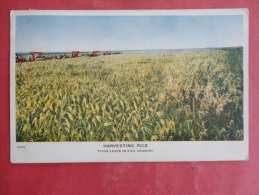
<box><xmin>16</xmin><ymin>15</ymin><xmax>243</xmax><ymax>52</ymax></box>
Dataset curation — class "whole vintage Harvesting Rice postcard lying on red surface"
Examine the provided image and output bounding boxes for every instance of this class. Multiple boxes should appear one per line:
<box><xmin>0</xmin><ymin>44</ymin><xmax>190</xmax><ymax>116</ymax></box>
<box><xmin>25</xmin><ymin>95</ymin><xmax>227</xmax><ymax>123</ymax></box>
<box><xmin>10</xmin><ymin>9</ymin><xmax>248</xmax><ymax>163</ymax></box>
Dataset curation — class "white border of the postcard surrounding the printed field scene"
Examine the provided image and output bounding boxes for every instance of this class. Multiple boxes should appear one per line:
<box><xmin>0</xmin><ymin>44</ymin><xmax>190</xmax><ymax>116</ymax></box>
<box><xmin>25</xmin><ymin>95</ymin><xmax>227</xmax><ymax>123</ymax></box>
<box><xmin>10</xmin><ymin>9</ymin><xmax>249</xmax><ymax>163</ymax></box>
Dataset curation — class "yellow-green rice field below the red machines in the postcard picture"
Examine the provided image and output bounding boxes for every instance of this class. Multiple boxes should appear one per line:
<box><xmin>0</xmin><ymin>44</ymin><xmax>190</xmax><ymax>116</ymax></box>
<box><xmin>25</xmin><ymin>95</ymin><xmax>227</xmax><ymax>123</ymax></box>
<box><xmin>15</xmin><ymin>49</ymin><xmax>244</xmax><ymax>142</ymax></box>
